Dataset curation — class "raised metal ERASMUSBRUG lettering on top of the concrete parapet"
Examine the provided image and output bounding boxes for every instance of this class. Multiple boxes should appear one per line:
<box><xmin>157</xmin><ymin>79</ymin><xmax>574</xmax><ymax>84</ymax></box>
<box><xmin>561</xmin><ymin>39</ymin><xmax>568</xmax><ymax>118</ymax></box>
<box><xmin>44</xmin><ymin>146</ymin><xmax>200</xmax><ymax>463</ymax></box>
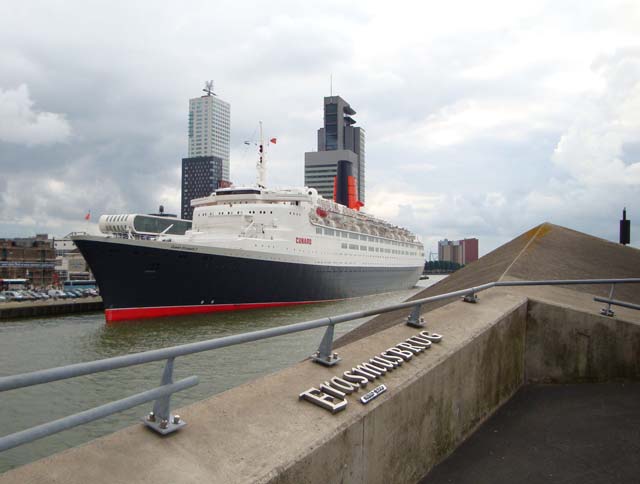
<box><xmin>300</xmin><ymin>331</ymin><xmax>442</xmax><ymax>413</ymax></box>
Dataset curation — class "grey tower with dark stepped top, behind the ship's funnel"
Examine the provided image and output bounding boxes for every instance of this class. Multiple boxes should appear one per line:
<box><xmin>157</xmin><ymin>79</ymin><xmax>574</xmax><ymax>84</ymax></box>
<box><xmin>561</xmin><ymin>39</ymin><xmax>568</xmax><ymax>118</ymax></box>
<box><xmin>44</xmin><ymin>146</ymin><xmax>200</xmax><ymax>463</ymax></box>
<box><xmin>304</xmin><ymin>96</ymin><xmax>365</xmax><ymax>203</ymax></box>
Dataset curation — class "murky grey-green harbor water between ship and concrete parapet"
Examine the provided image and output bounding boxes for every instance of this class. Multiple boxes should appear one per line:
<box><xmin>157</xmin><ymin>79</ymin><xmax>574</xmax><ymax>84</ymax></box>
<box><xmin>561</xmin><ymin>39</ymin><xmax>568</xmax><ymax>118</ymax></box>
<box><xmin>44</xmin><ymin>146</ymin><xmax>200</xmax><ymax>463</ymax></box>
<box><xmin>0</xmin><ymin>276</ymin><xmax>446</xmax><ymax>472</ymax></box>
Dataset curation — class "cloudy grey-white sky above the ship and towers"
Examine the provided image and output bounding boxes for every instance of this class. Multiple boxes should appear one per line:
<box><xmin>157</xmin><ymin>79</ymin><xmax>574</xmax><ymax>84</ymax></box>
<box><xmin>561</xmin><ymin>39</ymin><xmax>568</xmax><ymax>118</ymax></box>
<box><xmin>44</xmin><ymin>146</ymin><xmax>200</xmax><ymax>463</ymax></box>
<box><xmin>0</xmin><ymin>0</ymin><xmax>640</xmax><ymax>254</ymax></box>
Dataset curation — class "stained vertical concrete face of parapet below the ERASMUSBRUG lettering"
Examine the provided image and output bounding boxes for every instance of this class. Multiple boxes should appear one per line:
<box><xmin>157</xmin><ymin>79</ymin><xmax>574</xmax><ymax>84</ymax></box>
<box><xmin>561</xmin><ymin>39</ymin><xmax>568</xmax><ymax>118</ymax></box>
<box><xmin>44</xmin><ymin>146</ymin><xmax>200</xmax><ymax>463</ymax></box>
<box><xmin>268</xmin><ymin>304</ymin><xmax>526</xmax><ymax>484</ymax></box>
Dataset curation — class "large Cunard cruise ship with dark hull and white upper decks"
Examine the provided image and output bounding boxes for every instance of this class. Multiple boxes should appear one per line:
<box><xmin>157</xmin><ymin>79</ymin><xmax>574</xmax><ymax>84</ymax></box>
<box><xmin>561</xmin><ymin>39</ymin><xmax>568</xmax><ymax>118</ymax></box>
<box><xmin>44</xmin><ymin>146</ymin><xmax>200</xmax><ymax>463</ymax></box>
<box><xmin>74</xmin><ymin>136</ymin><xmax>424</xmax><ymax>322</ymax></box>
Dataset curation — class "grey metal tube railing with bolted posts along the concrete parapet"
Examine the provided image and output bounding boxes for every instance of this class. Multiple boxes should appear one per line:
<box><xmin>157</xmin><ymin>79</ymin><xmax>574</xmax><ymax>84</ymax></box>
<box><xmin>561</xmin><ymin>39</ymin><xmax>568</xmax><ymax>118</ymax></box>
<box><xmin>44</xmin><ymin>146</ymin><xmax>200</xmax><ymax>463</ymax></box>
<box><xmin>0</xmin><ymin>278</ymin><xmax>640</xmax><ymax>452</ymax></box>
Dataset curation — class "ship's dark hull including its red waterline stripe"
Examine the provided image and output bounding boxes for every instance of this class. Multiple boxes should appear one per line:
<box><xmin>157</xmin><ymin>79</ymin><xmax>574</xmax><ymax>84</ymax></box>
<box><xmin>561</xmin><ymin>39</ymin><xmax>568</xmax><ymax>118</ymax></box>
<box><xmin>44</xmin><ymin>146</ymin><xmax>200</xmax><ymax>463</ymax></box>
<box><xmin>75</xmin><ymin>237</ymin><xmax>423</xmax><ymax>322</ymax></box>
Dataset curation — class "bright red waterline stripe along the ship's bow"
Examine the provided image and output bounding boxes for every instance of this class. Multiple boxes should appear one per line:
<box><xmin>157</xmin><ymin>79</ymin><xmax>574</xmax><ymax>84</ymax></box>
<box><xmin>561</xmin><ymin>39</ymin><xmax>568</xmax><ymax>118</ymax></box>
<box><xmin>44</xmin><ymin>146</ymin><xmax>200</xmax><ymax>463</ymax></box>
<box><xmin>104</xmin><ymin>300</ymin><xmax>336</xmax><ymax>323</ymax></box>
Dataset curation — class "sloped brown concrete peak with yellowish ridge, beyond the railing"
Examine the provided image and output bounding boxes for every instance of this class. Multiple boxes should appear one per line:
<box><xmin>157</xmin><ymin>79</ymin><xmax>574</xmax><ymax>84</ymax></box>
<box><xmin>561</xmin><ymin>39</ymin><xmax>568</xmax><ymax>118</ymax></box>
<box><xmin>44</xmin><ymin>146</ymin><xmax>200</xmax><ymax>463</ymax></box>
<box><xmin>335</xmin><ymin>222</ymin><xmax>640</xmax><ymax>347</ymax></box>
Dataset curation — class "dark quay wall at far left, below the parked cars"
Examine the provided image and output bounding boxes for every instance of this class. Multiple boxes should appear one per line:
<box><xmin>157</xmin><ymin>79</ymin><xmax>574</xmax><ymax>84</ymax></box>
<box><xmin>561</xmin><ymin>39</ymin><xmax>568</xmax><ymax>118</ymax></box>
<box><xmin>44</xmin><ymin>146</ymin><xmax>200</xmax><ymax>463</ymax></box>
<box><xmin>0</xmin><ymin>296</ymin><xmax>103</xmax><ymax>320</ymax></box>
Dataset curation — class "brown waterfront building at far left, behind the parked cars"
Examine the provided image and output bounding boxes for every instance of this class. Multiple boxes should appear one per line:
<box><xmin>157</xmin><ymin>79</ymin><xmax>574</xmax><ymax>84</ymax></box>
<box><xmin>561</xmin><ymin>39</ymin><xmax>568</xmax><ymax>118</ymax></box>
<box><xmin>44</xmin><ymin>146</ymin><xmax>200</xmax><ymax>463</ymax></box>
<box><xmin>0</xmin><ymin>234</ymin><xmax>56</xmax><ymax>287</ymax></box>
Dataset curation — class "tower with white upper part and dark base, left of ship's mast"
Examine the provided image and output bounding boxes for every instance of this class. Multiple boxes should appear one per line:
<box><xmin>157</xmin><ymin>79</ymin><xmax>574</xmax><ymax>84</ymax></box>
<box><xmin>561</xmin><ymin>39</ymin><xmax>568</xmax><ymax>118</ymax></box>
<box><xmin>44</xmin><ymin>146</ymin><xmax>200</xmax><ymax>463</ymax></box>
<box><xmin>180</xmin><ymin>82</ymin><xmax>231</xmax><ymax>220</ymax></box>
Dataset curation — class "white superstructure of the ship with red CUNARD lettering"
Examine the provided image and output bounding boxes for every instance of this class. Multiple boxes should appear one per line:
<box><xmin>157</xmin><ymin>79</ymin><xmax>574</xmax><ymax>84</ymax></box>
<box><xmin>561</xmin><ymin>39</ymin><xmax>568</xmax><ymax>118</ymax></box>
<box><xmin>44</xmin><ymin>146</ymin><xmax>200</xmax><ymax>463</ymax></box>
<box><xmin>160</xmin><ymin>187</ymin><xmax>424</xmax><ymax>267</ymax></box>
